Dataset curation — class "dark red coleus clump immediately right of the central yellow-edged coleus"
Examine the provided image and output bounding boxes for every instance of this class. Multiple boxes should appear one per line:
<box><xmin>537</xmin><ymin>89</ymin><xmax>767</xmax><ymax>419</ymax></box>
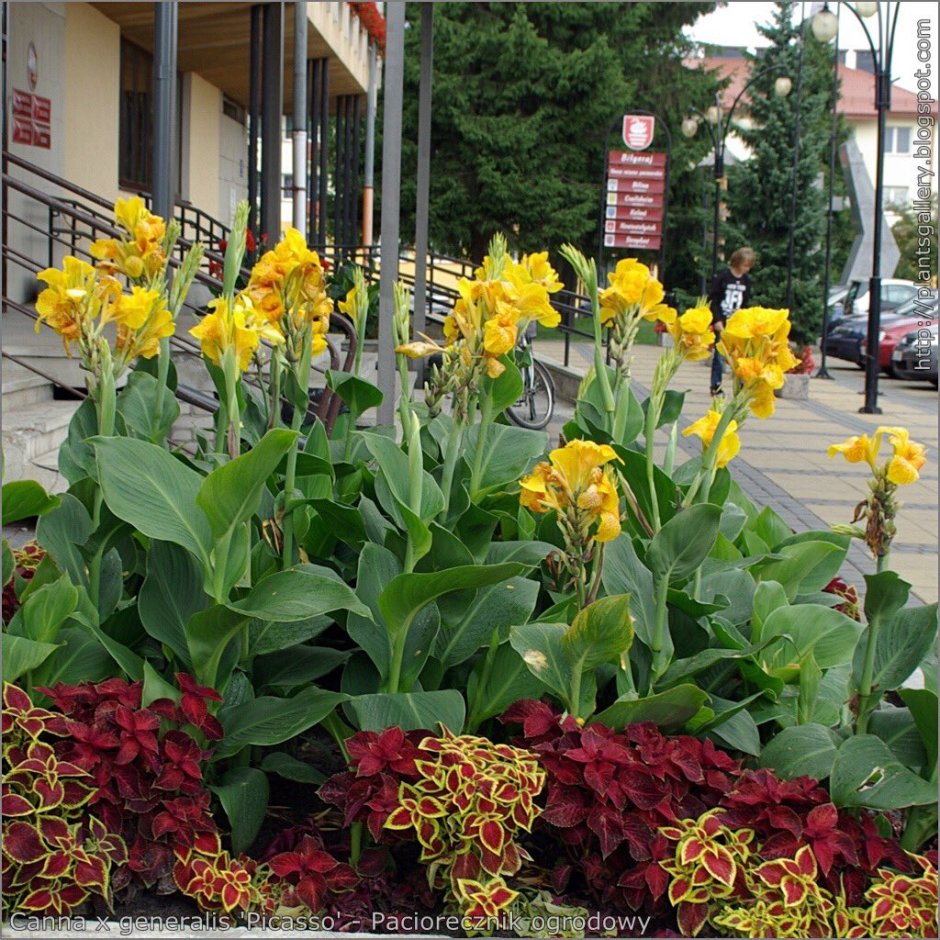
<box><xmin>501</xmin><ymin>700</ymin><xmax>741</xmax><ymax>913</ymax></box>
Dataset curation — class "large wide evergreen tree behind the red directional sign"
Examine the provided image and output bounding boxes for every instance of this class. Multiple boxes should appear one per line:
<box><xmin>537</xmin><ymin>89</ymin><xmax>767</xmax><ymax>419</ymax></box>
<box><xmin>390</xmin><ymin>3</ymin><xmax>715</xmax><ymax>288</ymax></box>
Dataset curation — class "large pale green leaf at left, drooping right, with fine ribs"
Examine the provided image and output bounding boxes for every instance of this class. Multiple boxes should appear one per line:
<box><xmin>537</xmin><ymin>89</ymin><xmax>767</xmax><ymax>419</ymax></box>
<box><xmin>94</xmin><ymin>437</ymin><xmax>212</xmax><ymax>571</ymax></box>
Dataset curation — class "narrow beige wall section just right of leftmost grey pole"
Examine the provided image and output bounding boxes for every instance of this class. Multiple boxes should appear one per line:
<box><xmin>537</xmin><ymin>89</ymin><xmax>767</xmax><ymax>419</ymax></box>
<box><xmin>180</xmin><ymin>72</ymin><xmax>222</xmax><ymax>218</ymax></box>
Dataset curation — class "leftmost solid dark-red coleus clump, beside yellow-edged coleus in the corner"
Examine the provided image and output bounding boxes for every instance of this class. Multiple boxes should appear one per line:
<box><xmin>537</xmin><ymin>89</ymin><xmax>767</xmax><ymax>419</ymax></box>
<box><xmin>40</xmin><ymin>675</ymin><xmax>221</xmax><ymax>893</ymax></box>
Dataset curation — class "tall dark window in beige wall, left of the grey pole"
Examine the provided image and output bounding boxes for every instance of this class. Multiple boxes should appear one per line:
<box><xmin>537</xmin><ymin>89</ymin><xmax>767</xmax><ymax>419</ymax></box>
<box><xmin>118</xmin><ymin>39</ymin><xmax>153</xmax><ymax>191</ymax></box>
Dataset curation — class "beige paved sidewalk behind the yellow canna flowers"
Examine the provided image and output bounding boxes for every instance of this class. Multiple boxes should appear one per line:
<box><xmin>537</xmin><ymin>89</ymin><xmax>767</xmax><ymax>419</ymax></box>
<box><xmin>538</xmin><ymin>340</ymin><xmax>940</xmax><ymax>603</ymax></box>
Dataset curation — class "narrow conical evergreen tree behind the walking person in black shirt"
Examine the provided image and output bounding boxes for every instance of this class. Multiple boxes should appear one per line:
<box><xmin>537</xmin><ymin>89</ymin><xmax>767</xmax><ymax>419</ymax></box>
<box><xmin>728</xmin><ymin>0</ymin><xmax>832</xmax><ymax>342</ymax></box>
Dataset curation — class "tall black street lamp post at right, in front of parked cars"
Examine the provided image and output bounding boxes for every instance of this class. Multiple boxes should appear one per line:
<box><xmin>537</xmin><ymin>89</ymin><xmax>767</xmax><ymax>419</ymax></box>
<box><xmin>813</xmin><ymin>0</ymin><xmax>901</xmax><ymax>415</ymax></box>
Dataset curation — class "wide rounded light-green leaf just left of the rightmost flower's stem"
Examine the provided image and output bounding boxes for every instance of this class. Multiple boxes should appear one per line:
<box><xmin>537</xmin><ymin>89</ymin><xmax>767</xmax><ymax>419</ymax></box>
<box><xmin>762</xmin><ymin>604</ymin><xmax>862</xmax><ymax>669</ymax></box>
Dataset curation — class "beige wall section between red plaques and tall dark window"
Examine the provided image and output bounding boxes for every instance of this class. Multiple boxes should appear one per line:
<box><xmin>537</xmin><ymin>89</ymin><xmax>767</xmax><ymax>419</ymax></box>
<box><xmin>62</xmin><ymin>3</ymin><xmax>121</xmax><ymax>199</ymax></box>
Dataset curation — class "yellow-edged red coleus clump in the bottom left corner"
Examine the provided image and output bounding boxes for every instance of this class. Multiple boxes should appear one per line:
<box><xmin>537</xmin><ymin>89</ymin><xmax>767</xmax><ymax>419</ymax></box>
<box><xmin>2</xmin><ymin>683</ymin><xmax>127</xmax><ymax>915</ymax></box>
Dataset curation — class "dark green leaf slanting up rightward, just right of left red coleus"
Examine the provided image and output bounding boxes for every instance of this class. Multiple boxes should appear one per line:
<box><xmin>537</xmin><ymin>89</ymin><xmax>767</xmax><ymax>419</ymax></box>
<box><xmin>215</xmin><ymin>686</ymin><xmax>347</xmax><ymax>758</ymax></box>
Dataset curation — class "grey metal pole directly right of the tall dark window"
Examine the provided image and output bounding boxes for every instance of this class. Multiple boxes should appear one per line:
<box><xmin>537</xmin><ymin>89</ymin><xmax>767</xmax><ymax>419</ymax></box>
<box><xmin>153</xmin><ymin>0</ymin><xmax>177</xmax><ymax>219</ymax></box>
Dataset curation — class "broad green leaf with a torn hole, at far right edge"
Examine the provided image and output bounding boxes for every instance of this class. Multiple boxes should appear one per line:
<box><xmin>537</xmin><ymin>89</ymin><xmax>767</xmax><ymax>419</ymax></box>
<box><xmin>829</xmin><ymin>734</ymin><xmax>937</xmax><ymax>809</ymax></box>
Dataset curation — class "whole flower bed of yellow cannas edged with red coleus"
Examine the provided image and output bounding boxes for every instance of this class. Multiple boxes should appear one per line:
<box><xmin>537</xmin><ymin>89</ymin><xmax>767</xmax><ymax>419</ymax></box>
<box><xmin>3</xmin><ymin>200</ymin><xmax>937</xmax><ymax>937</ymax></box>
